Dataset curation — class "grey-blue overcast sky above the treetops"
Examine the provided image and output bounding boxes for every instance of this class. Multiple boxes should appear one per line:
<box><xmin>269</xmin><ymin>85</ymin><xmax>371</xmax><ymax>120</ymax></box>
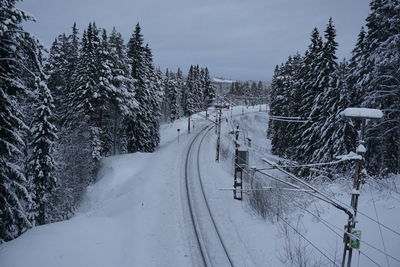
<box><xmin>19</xmin><ymin>0</ymin><xmax>369</xmax><ymax>80</ymax></box>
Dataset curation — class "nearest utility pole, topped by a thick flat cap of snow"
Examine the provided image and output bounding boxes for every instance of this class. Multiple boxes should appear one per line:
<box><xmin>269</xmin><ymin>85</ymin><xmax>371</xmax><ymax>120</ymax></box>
<box><xmin>341</xmin><ymin>108</ymin><xmax>383</xmax><ymax>267</ymax></box>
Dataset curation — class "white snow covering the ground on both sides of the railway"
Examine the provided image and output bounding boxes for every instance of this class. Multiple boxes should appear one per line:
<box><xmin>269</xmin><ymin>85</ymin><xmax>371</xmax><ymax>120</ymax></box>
<box><xmin>0</xmin><ymin>106</ymin><xmax>400</xmax><ymax>267</ymax></box>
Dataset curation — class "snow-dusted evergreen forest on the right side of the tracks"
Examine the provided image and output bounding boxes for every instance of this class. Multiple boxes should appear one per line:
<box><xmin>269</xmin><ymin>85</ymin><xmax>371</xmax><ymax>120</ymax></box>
<box><xmin>268</xmin><ymin>0</ymin><xmax>400</xmax><ymax>178</ymax></box>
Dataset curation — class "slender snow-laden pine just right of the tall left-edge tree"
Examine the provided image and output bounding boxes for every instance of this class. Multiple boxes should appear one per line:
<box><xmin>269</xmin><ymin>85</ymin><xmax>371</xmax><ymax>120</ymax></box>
<box><xmin>29</xmin><ymin>77</ymin><xmax>57</xmax><ymax>225</ymax></box>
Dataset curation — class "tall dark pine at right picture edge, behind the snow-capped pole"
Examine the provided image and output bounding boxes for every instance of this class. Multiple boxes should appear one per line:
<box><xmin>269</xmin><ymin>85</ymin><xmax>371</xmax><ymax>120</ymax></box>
<box><xmin>359</xmin><ymin>0</ymin><xmax>400</xmax><ymax>173</ymax></box>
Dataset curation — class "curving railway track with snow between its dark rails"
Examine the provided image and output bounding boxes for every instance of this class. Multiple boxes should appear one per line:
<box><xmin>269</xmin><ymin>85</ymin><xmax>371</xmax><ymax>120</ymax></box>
<box><xmin>184</xmin><ymin>126</ymin><xmax>235</xmax><ymax>267</ymax></box>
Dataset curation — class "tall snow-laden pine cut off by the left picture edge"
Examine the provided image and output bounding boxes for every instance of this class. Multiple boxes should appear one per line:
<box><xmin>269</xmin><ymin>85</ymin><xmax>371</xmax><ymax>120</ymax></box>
<box><xmin>0</xmin><ymin>0</ymin><xmax>39</xmax><ymax>243</ymax></box>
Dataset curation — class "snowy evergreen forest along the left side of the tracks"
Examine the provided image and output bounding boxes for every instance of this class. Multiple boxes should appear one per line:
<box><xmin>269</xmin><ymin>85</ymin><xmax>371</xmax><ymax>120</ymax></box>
<box><xmin>0</xmin><ymin>0</ymin><xmax>215</xmax><ymax>243</ymax></box>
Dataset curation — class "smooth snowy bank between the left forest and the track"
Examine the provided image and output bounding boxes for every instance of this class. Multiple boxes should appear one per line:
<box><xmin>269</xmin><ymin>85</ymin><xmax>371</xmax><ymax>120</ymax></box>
<box><xmin>0</xmin><ymin>117</ymin><xmax>203</xmax><ymax>267</ymax></box>
